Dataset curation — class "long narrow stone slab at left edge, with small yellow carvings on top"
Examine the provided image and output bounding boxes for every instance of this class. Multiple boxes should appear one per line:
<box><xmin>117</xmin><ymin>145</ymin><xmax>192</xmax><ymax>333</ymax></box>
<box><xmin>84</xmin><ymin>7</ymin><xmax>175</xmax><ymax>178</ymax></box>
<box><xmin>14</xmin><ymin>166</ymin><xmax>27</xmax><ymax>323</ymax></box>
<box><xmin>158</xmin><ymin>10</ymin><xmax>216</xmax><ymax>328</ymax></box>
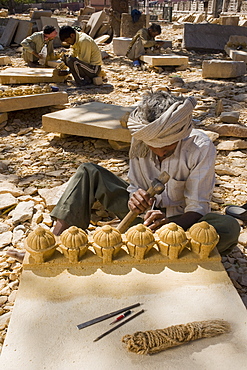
<box><xmin>0</xmin><ymin>91</ymin><xmax>68</xmax><ymax>112</ymax></box>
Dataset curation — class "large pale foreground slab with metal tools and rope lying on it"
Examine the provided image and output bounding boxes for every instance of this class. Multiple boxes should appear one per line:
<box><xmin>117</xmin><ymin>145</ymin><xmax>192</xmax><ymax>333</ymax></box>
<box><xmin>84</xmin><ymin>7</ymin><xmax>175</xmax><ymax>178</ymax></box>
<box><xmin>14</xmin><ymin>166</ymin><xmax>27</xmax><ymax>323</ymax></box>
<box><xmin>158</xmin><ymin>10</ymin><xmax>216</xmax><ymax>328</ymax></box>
<box><xmin>0</xmin><ymin>262</ymin><xmax>247</xmax><ymax>370</ymax></box>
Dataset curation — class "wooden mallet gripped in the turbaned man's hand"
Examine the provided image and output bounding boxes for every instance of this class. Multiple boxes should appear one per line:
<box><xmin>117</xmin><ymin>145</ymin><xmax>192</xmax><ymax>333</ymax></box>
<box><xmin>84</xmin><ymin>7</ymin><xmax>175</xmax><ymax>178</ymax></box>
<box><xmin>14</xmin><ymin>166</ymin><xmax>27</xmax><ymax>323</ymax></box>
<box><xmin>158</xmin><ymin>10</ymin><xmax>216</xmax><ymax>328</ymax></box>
<box><xmin>117</xmin><ymin>171</ymin><xmax>170</xmax><ymax>234</ymax></box>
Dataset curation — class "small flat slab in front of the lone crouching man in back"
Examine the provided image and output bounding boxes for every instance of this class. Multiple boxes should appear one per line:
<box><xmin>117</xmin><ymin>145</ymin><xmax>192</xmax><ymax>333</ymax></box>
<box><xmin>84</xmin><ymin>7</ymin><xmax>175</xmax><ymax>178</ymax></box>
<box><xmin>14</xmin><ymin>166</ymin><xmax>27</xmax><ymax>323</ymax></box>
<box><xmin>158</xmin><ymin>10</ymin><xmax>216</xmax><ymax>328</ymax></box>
<box><xmin>140</xmin><ymin>54</ymin><xmax>189</xmax><ymax>66</ymax></box>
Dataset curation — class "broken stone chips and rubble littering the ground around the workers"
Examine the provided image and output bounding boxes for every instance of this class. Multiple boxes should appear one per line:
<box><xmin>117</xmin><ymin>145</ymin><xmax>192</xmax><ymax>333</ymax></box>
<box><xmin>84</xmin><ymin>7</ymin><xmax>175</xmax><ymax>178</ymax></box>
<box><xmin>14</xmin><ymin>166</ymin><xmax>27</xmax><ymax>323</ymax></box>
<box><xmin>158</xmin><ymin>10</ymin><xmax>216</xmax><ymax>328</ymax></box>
<box><xmin>0</xmin><ymin>9</ymin><xmax>247</xmax><ymax>356</ymax></box>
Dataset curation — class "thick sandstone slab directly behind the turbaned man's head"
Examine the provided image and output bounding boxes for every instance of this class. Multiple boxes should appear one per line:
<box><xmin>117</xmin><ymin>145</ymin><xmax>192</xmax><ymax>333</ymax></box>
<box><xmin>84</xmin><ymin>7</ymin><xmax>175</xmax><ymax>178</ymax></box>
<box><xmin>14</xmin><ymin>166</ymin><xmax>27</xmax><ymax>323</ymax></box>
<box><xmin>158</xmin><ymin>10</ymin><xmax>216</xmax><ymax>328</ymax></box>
<box><xmin>42</xmin><ymin>102</ymin><xmax>133</xmax><ymax>142</ymax></box>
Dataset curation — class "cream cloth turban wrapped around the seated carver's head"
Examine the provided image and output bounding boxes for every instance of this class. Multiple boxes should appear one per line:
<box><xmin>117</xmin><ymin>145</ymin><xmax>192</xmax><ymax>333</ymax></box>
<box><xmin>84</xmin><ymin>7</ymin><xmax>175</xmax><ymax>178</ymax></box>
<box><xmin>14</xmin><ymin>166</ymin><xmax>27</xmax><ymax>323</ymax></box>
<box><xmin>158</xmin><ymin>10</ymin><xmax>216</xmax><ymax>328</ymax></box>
<box><xmin>127</xmin><ymin>96</ymin><xmax>196</xmax><ymax>157</ymax></box>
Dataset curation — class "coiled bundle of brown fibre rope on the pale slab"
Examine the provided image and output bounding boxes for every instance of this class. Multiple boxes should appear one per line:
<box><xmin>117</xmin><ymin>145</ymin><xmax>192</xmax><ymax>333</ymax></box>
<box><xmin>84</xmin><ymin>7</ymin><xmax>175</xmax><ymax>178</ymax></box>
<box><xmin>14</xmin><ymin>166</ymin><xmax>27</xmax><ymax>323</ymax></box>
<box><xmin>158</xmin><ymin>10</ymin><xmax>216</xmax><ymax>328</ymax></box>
<box><xmin>122</xmin><ymin>320</ymin><xmax>230</xmax><ymax>355</ymax></box>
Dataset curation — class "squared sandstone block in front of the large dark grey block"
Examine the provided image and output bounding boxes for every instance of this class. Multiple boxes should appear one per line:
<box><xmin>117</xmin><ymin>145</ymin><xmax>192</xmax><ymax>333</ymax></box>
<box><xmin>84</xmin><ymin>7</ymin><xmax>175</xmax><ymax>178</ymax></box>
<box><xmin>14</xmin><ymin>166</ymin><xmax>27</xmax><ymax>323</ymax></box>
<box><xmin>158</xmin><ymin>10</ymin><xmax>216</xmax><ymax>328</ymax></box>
<box><xmin>202</xmin><ymin>59</ymin><xmax>246</xmax><ymax>79</ymax></box>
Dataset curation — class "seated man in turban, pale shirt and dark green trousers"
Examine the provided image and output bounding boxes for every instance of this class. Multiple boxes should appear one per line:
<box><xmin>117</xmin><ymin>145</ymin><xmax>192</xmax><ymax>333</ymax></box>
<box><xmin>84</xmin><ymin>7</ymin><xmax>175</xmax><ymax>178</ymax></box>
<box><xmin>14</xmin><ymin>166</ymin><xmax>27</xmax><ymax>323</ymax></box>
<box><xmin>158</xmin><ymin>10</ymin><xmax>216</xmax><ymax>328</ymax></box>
<box><xmin>7</xmin><ymin>91</ymin><xmax>240</xmax><ymax>262</ymax></box>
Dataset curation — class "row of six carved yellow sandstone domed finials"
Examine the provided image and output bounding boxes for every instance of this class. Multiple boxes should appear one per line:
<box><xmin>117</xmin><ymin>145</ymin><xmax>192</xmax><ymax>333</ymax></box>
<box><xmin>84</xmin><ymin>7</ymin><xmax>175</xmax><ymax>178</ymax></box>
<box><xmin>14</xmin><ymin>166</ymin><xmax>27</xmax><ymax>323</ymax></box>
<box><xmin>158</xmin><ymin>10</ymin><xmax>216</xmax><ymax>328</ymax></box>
<box><xmin>24</xmin><ymin>221</ymin><xmax>220</xmax><ymax>268</ymax></box>
